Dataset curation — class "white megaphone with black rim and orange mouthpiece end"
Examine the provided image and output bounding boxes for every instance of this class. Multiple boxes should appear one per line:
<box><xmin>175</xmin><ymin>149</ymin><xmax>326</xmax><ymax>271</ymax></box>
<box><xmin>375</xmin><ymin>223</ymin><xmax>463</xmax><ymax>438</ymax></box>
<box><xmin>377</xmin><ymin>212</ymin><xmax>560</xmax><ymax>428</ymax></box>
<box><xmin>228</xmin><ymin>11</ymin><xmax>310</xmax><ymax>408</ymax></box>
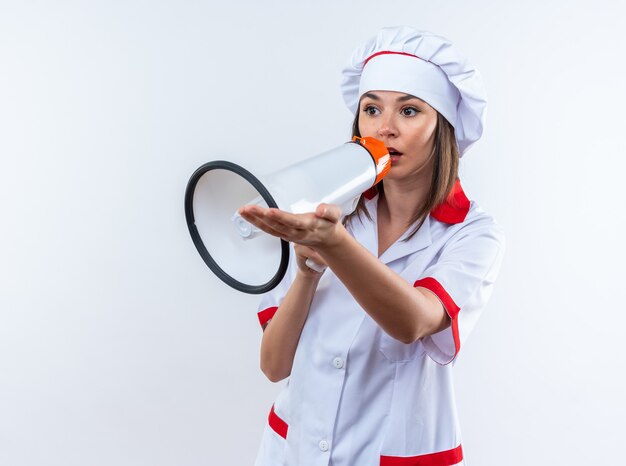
<box><xmin>185</xmin><ymin>136</ymin><xmax>391</xmax><ymax>294</ymax></box>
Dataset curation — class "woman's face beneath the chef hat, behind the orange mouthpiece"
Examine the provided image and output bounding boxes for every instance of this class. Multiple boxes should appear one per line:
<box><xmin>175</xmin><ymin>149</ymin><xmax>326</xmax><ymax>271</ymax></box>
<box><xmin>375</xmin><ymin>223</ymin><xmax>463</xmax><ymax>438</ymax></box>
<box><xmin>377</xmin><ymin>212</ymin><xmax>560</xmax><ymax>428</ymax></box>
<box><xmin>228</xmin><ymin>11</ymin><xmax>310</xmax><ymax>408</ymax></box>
<box><xmin>359</xmin><ymin>91</ymin><xmax>437</xmax><ymax>180</ymax></box>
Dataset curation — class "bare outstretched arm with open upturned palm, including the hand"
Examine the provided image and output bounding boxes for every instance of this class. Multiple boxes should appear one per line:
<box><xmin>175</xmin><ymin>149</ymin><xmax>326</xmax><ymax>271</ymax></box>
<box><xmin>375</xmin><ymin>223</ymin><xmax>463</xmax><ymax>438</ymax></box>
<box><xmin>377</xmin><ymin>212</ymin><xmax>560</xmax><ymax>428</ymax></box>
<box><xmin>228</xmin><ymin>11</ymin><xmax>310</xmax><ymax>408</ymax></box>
<box><xmin>240</xmin><ymin>205</ymin><xmax>450</xmax><ymax>343</ymax></box>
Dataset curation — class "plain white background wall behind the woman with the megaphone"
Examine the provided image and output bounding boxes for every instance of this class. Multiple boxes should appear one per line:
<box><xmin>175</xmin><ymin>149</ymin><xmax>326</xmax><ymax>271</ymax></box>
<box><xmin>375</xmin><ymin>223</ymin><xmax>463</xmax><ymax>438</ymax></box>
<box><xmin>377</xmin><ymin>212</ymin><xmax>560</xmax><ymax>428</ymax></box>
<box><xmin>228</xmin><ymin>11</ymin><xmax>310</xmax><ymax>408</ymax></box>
<box><xmin>0</xmin><ymin>0</ymin><xmax>626</xmax><ymax>466</ymax></box>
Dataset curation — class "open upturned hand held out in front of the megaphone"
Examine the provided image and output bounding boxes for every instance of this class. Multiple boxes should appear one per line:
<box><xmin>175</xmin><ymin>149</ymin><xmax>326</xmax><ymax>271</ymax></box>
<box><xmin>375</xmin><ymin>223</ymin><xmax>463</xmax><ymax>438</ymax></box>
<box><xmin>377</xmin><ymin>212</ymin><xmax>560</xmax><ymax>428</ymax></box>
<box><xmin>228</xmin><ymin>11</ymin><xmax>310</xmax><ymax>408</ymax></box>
<box><xmin>239</xmin><ymin>204</ymin><xmax>345</xmax><ymax>248</ymax></box>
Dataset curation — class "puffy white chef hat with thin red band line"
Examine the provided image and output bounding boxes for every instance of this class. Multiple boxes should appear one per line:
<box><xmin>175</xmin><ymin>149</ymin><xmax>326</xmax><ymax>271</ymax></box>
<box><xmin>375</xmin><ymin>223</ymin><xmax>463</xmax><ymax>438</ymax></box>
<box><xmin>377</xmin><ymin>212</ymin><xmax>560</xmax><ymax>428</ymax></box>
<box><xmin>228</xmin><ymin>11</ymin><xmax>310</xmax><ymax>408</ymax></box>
<box><xmin>341</xmin><ymin>26</ymin><xmax>487</xmax><ymax>156</ymax></box>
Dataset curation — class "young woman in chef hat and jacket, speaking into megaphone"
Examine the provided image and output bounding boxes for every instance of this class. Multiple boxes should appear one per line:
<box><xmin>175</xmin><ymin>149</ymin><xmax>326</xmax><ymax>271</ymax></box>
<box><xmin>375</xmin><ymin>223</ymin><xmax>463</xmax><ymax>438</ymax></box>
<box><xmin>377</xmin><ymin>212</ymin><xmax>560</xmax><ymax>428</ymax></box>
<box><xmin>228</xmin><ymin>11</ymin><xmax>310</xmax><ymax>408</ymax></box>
<box><xmin>240</xmin><ymin>27</ymin><xmax>504</xmax><ymax>466</ymax></box>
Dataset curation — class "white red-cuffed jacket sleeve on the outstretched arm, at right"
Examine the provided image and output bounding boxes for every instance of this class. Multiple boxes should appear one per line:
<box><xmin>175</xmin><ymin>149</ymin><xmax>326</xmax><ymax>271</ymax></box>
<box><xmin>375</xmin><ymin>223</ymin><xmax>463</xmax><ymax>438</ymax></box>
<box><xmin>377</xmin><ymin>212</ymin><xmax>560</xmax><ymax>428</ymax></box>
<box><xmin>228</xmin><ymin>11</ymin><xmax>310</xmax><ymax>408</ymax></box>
<box><xmin>414</xmin><ymin>221</ymin><xmax>505</xmax><ymax>364</ymax></box>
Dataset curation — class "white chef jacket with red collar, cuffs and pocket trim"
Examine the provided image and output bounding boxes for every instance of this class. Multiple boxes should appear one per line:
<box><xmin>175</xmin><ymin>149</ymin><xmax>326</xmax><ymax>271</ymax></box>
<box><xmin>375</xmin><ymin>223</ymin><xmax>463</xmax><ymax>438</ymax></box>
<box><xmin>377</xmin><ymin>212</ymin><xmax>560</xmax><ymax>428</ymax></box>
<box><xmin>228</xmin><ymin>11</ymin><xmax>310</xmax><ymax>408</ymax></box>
<box><xmin>255</xmin><ymin>180</ymin><xmax>504</xmax><ymax>466</ymax></box>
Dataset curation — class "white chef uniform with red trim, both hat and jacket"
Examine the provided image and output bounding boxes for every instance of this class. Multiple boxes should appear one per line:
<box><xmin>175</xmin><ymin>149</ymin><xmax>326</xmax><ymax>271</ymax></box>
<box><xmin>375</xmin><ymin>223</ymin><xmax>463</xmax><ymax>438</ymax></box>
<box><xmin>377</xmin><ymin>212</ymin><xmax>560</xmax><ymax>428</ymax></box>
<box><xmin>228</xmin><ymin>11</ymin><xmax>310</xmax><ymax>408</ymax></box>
<box><xmin>255</xmin><ymin>27</ymin><xmax>504</xmax><ymax>466</ymax></box>
